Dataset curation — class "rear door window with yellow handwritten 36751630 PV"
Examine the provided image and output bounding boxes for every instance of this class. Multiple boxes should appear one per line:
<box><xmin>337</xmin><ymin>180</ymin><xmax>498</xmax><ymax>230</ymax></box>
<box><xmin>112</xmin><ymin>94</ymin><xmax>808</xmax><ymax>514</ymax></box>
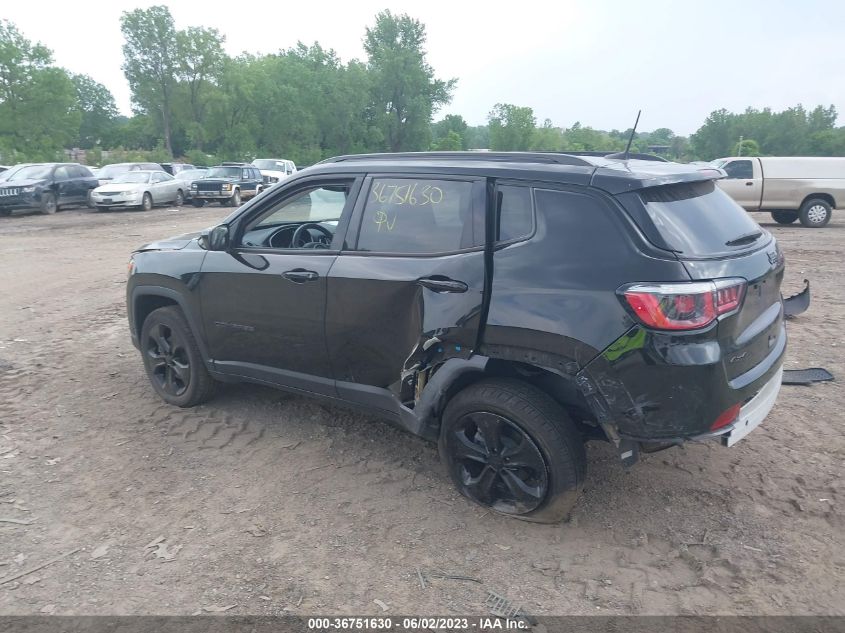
<box><xmin>358</xmin><ymin>178</ymin><xmax>484</xmax><ymax>254</ymax></box>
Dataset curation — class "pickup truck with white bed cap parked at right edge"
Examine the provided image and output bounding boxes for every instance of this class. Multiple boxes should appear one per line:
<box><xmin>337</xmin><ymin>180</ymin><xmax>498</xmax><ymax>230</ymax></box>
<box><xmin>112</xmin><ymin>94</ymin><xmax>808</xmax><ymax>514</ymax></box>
<box><xmin>712</xmin><ymin>156</ymin><xmax>845</xmax><ymax>228</ymax></box>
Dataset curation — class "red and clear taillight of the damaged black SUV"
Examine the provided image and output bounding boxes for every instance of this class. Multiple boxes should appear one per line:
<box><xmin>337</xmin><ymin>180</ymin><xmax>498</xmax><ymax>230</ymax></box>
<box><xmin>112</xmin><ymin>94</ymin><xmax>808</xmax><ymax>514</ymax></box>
<box><xmin>619</xmin><ymin>279</ymin><xmax>746</xmax><ymax>330</ymax></box>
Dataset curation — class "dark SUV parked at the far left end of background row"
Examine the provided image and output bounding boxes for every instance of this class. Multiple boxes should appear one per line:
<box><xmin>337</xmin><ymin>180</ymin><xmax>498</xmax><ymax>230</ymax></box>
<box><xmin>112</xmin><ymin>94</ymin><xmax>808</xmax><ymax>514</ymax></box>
<box><xmin>0</xmin><ymin>163</ymin><xmax>97</xmax><ymax>215</ymax></box>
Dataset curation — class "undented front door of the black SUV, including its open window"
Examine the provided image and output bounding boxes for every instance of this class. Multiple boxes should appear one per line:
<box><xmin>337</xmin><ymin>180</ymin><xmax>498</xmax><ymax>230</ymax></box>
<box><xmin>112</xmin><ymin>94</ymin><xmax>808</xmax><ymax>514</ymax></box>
<box><xmin>200</xmin><ymin>179</ymin><xmax>362</xmax><ymax>395</ymax></box>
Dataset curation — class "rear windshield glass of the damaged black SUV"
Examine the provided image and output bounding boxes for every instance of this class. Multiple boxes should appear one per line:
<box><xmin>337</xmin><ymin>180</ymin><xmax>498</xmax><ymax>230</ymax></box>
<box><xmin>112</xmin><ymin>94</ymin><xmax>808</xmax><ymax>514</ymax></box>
<box><xmin>640</xmin><ymin>180</ymin><xmax>766</xmax><ymax>257</ymax></box>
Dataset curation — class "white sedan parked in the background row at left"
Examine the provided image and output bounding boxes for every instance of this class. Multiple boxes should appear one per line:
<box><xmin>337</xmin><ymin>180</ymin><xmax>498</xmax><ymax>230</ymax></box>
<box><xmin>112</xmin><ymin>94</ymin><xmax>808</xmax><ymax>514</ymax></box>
<box><xmin>91</xmin><ymin>170</ymin><xmax>185</xmax><ymax>211</ymax></box>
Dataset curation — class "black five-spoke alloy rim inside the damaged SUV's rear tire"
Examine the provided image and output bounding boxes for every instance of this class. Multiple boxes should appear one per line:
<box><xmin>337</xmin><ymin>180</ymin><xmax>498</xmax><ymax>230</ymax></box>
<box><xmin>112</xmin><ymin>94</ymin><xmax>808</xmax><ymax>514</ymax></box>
<box><xmin>445</xmin><ymin>411</ymin><xmax>549</xmax><ymax>514</ymax></box>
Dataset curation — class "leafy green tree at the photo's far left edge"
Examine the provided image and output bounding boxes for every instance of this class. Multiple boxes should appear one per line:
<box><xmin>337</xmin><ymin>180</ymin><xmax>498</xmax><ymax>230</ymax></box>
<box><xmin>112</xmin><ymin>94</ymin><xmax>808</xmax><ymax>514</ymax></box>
<box><xmin>0</xmin><ymin>20</ymin><xmax>80</xmax><ymax>162</ymax></box>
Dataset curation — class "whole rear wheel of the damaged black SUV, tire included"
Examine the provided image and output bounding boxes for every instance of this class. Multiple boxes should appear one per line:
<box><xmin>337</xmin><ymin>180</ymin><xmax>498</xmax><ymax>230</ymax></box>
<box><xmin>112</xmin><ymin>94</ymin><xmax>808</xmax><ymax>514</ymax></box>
<box><xmin>438</xmin><ymin>378</ymin><xmax>587</xmax><ymax>523</ymax></box>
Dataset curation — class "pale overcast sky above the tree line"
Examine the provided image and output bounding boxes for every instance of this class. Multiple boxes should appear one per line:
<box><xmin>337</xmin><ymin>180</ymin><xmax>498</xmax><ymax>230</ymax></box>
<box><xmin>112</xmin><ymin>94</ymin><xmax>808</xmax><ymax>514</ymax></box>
<box><xmin>6</xmin><ymin>0</ymin><xmax>845</xmax><ymax>135</ymax></box>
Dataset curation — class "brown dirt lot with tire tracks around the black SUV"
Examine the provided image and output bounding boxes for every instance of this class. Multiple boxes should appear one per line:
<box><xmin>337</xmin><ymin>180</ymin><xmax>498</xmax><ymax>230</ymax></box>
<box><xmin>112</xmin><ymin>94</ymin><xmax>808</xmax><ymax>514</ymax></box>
<box><xmin>0</xmin><ymin>207</ymin><xmax>845</xmax><ymax>615</ymax></box>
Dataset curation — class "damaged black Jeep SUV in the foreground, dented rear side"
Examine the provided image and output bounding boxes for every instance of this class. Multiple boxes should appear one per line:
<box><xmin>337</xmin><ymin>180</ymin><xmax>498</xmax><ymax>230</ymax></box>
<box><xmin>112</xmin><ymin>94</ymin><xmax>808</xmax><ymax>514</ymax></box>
<box><xmin>127</xmin><ymin>152</ymin><xmax>786</xmax><ymax>522</ymax></box>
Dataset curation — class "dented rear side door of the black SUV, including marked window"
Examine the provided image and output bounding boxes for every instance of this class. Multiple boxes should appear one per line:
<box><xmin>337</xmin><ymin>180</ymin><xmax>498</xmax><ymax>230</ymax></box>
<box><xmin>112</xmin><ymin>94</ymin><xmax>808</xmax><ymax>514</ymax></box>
<box><xmin>326</xmin><ymin>174</ymin><xmax>486</xmax><ymax>411</ymax></box>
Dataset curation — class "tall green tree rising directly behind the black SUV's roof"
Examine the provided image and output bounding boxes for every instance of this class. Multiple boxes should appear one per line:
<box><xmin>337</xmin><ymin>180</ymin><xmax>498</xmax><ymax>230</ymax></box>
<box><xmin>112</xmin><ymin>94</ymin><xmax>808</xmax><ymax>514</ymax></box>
<box><xmin>364</xmin><ymin>11</ymin><xmax>456</xmax><ymax>152</ymax></box>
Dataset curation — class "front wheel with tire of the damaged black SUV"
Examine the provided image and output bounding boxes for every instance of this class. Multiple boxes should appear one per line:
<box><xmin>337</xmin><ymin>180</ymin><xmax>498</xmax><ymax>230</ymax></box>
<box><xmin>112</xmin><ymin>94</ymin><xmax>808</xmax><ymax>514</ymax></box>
<box><xmin>141</xmin><ymin>306</ymin><xmax>214</xmax><ymax>407</ymax></box>
